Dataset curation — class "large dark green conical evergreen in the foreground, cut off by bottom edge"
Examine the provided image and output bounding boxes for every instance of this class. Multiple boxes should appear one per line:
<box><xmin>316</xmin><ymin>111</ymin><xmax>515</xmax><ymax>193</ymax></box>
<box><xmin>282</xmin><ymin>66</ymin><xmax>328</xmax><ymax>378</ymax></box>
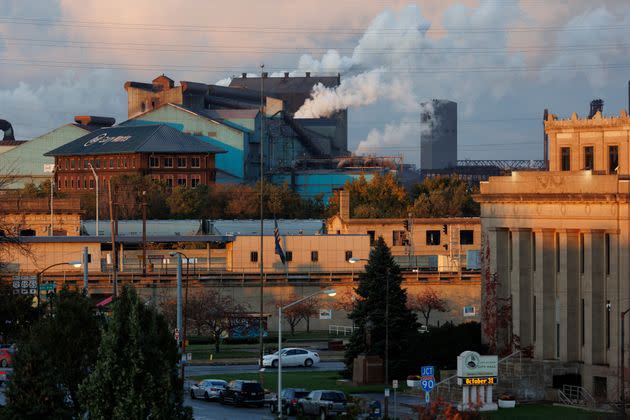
<box><xmin>80</xmin><ymin>286</ymin><xmax>192</xmax><ymax>419</ymax></box>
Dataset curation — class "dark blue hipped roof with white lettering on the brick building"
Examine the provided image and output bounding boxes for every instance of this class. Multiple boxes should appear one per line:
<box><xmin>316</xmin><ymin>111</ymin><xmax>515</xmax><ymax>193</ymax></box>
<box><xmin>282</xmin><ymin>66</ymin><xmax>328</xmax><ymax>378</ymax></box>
<box><xmin>45</xmin><ymin>124</ymin><xmax>226</xmax><ymax>156</ymax></box>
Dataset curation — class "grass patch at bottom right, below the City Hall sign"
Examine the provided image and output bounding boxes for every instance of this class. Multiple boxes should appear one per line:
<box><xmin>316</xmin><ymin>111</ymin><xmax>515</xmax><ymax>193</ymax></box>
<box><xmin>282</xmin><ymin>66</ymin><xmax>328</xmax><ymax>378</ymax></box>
<box><xmin>484</xmin><ymin>404</ymin><xmax>610</xmax><ymax>420</ymax></box>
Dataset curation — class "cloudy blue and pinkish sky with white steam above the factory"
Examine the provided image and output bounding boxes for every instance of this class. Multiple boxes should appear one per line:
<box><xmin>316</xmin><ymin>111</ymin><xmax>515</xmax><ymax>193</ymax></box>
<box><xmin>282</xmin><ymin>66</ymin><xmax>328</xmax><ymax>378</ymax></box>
<box><xmin>0</xmin><ymin>0</ymin><xmax>630</xmax><ymax>167</ymax></box>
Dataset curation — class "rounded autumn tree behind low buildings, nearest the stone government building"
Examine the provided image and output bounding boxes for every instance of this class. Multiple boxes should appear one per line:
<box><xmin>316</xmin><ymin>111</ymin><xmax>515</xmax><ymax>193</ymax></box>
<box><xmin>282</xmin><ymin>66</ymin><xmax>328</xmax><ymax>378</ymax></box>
<box><xmin>411</xmin><ymin>176</ymin><xmax>479</xmax><ymax>217</ymax></box>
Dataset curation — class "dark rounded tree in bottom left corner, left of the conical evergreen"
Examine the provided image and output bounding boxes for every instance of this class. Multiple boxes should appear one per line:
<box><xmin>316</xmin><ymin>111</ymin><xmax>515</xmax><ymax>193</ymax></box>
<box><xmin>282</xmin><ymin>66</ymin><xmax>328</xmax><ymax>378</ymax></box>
<box><xmin>6</xmin><ymin>289</ymin><xmax>102</xmax><ymax>418</ymax></box>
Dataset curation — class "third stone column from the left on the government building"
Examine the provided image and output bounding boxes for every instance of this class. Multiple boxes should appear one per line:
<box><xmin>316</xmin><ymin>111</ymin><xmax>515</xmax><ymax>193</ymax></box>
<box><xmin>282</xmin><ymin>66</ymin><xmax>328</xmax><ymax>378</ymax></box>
<box><xmin>534</xmin><ymin>229</ymin><xmax>556</xmax><ymax>359</ymax></box>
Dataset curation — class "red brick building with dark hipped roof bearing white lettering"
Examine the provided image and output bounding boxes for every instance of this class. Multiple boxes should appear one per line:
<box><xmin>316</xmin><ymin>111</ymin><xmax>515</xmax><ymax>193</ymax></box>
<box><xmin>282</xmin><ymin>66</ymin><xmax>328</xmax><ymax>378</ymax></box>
<box><xmin>45</xmin><ymin>124</ymin><xmax>225</xmax><ymax>192</ymax></box>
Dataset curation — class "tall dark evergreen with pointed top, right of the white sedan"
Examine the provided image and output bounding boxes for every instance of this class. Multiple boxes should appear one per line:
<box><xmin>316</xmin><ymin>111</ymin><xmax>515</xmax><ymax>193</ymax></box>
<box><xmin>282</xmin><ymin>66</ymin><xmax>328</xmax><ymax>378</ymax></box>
<box><xmin>345</xmin><ymin>237</ymin><xmax>418</xmax><ymax>378</ymax></box>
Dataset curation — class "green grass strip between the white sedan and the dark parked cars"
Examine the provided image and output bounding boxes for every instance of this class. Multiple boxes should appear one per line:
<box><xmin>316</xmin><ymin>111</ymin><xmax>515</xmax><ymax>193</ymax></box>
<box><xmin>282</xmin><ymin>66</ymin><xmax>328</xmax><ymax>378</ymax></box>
<box><xmin>192</xmin><ymin>369</ymin><xmax>383</xmax><ymax>393</ymax></box>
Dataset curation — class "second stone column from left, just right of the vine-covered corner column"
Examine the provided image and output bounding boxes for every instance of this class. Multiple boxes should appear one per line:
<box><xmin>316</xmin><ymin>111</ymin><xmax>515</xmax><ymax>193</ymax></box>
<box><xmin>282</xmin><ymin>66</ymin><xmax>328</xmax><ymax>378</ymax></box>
<box><xmin>511</xmin><ymin>229</ymin><xmax>532</xmax><ymax>347</ymax></box>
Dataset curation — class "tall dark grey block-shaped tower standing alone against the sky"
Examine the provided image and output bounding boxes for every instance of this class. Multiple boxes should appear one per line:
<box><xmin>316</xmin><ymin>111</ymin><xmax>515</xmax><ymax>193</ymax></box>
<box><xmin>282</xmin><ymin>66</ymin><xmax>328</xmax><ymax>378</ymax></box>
<box><xmin>420</xmin><ymin>99</ymin><xmax>457</xmax><ymax>170</ymax></box>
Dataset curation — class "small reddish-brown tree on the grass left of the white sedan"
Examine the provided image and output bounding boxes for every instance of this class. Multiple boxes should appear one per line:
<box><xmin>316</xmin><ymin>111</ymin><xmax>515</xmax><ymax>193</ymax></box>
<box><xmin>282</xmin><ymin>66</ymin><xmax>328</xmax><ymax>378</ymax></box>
<box><xmin>204</xmin><ymin>290</ymin><xmax>247</xmax><ymax>353</ymax></box>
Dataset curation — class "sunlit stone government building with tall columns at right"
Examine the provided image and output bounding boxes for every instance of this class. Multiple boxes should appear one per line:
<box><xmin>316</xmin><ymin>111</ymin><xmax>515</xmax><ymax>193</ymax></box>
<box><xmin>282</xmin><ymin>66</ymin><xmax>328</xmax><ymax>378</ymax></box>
<box><xmin>476</xmin><ymin>103</ymin><xmax>630</xmax><ymax>401</ymax></box>
